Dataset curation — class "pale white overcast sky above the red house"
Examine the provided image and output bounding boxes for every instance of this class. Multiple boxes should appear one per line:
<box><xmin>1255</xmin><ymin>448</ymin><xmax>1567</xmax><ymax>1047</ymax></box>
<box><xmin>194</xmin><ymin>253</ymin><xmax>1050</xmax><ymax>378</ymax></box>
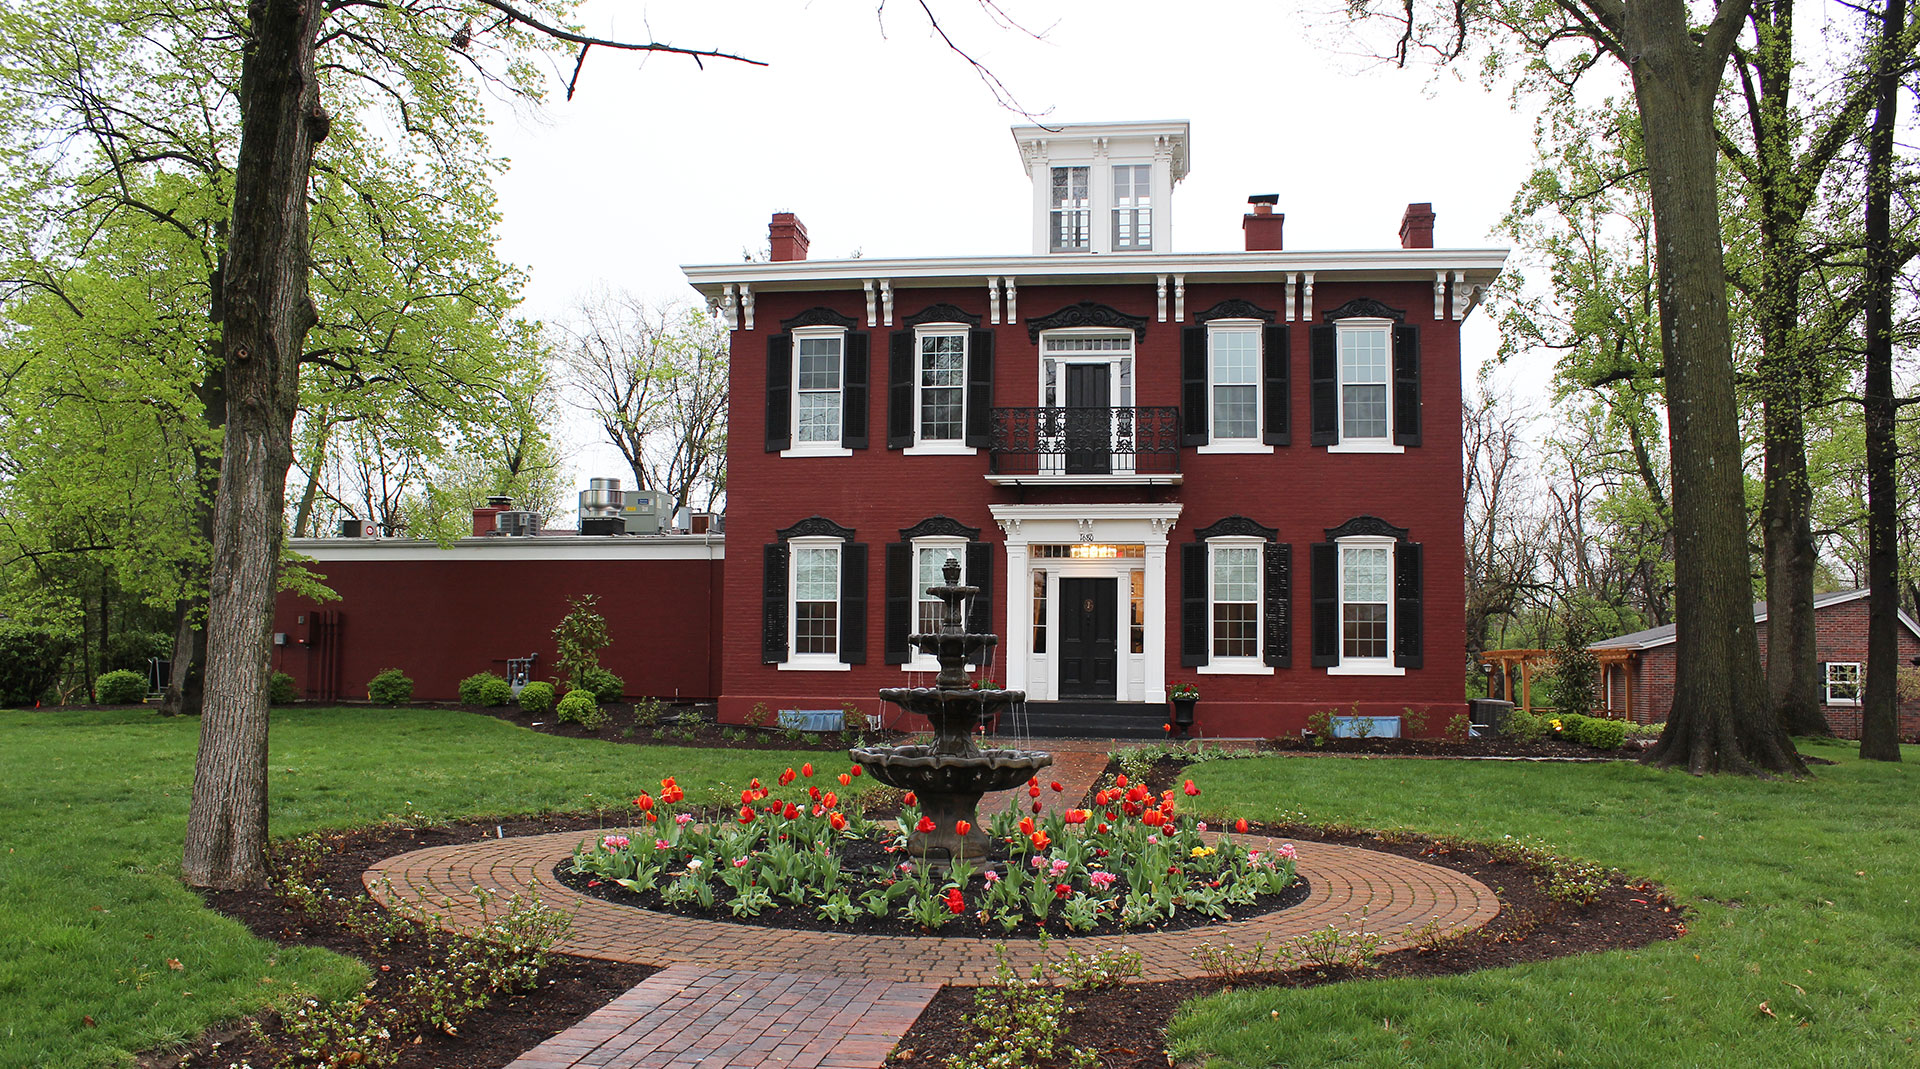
<box><xmin>493</xmin><ymin>0</ymin><xmax>1589</xmax><ymax>502</ymax></box>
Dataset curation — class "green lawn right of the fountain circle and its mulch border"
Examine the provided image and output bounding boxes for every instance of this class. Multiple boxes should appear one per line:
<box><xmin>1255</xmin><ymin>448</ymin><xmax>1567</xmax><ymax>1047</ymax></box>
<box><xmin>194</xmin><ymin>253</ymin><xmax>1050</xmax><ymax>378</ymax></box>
<box><xmin>1169</xmin><ymin>743</ymin><xmax>1920</xmax><ymax>1069</ymax></box>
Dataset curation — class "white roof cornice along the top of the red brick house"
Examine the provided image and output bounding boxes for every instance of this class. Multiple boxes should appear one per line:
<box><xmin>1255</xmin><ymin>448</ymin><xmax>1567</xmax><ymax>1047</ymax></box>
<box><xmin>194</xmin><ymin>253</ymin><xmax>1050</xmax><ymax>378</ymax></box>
<box><xmin>682</xmin><ymin>249</ymin><xmax>1507</xmax><ymax>301</ymax></box>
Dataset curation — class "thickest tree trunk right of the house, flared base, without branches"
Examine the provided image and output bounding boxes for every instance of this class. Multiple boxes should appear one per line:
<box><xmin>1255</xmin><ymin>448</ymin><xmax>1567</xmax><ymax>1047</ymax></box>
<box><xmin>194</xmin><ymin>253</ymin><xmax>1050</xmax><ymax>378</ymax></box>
<box><xmin>1622</xmin><ymin>0</ymin><xmax>1805</xmax><ymax>773</ymax></box>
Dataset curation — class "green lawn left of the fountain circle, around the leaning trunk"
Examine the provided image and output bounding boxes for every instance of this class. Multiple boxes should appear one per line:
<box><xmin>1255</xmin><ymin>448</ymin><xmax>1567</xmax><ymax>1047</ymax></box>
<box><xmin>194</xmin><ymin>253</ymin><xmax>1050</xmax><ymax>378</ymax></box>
<box><xmin>0</xmin><ymin>708</ymin><xmax>856</xmax><ymax>1069</ymax></box>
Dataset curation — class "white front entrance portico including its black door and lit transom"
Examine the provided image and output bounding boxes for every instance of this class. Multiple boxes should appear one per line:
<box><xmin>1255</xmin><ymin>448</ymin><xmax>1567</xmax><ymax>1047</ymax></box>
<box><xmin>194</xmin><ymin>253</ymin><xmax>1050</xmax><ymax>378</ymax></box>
<box><xmin>991</xmin><ymin>503</ymin><xmax>1181</xmax><ymax>702</ymax></box>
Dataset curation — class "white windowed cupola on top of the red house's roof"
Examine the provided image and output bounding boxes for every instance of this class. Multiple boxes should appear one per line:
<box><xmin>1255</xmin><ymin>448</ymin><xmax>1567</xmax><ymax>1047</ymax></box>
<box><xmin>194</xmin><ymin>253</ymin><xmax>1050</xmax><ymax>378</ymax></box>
<box><xmin>1014</xmin><ymin>123</ymin><xmax>1190</xmax><ymax>255</ymax></box>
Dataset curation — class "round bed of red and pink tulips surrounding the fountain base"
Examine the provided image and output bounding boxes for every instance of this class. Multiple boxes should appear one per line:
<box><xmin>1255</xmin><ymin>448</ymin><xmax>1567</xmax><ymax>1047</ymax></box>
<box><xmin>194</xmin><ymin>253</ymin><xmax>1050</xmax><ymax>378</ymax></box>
<box><xmin>559</xmin><ymin>764</ymin><xmax>1302</xmax><ymax>935</ymax></box>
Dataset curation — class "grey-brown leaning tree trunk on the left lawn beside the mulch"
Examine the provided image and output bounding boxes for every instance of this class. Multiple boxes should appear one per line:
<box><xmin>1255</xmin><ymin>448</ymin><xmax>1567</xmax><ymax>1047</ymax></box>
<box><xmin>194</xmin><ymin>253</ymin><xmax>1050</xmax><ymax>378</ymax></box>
<box><xmin>184</xmin><ymin>0</ymin><xmax>326</xmax><ymax>889</ymax></box>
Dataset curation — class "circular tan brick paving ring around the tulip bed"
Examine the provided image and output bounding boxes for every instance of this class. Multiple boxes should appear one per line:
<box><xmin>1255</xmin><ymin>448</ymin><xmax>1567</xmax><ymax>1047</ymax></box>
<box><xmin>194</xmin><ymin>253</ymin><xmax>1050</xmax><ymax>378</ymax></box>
<box><xmin>365</xmin><ymin>831</ymin><xmax>1500</xmax><ymax>985</ymax></box>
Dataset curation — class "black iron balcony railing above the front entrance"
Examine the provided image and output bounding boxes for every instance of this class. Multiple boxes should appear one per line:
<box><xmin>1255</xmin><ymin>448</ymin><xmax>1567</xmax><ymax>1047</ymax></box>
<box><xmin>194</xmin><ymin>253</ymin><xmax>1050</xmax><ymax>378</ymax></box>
<box><xmin>987</xmin><ymin>405</ymin><xmax>1181</xmax><ymax>476</ymax></box>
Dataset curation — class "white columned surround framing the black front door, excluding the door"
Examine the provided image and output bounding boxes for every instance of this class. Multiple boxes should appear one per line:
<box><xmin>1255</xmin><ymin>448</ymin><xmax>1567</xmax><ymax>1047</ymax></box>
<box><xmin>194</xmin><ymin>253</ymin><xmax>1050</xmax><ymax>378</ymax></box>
<box><xmin>989</xmin><ymin>503</ymin><xmax>1181</xmax><ymax>702</ymax></box>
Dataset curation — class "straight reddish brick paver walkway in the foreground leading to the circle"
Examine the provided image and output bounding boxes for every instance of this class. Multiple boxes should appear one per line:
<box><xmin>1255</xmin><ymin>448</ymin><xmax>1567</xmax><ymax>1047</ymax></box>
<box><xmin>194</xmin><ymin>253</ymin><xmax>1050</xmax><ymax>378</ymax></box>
<box><xmin>507</xmin><ymin>965</ymin><xmax>941</xmax><ymax>1069</ymax></box>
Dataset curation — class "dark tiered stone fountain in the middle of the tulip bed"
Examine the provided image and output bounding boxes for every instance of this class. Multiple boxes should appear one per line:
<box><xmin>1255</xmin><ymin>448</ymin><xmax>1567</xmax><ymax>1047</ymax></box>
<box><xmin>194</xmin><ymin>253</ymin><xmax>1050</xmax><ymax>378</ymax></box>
<box><xmin>847</xmin><ymin>557</ymin><xmax>1054</xmax><ymax>864</ymax></box>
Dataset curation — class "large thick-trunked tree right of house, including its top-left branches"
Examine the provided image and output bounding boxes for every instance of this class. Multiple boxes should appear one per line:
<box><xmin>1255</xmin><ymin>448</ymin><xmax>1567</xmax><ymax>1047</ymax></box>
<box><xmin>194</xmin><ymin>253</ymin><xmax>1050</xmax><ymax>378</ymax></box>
<box><xmin>1357</xmin><ymin>0</ymin><xmax>1805</xmax><ymax>773</ymax></box>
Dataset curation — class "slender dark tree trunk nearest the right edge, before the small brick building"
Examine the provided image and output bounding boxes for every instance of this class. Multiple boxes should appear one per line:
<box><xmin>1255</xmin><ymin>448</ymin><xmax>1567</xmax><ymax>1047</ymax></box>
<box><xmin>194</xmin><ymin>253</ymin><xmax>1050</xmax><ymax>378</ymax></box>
<box><xmin>1860</xmin><ymin>0</ymin><xmax>1907</xmax><ymax>760</ymax></box>
